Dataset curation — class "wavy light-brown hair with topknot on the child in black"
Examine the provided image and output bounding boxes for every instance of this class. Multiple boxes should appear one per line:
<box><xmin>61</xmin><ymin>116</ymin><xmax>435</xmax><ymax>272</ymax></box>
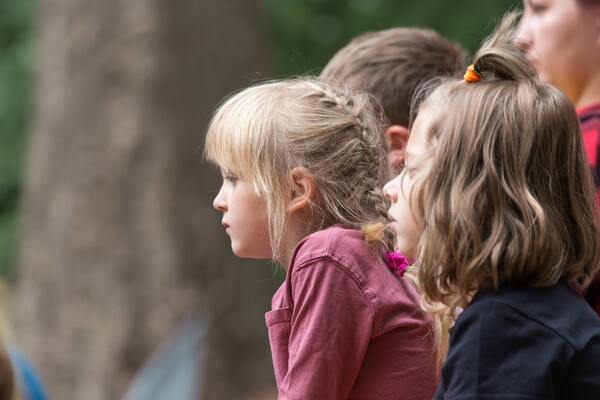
<box><xmin>413</xmin><ymin>13</ymin><xmax>600</xmax><ymax>357</ymax></box>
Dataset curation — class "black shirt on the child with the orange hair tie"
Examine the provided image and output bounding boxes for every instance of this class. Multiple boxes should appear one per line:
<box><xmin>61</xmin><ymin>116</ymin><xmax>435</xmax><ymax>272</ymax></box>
<box><xmin>434</xmin><ymin>283</ymin><xmax>600</xmax><ymax>400</ymax></box>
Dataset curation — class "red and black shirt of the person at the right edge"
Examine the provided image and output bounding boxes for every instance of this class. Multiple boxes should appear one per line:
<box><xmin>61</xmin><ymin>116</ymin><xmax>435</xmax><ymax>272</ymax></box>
<box><xmin>577</xmin><ymin>104</ymin><xmax>600</xmax><ymax>315</ymax></box>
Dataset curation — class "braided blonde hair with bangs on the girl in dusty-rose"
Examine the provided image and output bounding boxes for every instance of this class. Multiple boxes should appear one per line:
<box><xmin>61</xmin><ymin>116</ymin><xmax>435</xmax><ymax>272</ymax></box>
<box><xmin>205</xmin><ymin>78</ymin><xmax>394</xmax><ymax>259</ymax></box>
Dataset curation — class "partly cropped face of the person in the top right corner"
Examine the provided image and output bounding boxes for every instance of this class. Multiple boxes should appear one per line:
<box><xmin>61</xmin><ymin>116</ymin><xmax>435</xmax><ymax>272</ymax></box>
<box><xmin>515</xmin><ymin>0</ymin><xmax>600</xmax><ymax>105</ymax></box>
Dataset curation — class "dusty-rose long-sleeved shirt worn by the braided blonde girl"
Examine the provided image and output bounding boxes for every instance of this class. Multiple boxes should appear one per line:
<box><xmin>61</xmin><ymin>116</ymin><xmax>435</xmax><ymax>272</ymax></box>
<box><xmin>266</xmin><ymin>227</ymin><xmax>436</xmax><ymax>400</ymax></box>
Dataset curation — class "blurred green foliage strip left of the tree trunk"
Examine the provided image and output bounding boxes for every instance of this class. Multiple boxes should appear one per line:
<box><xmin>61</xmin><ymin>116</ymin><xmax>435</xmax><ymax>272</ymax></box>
<box><xmin>0</xmin><ymin>0</ymin><xmax>33</xmax><ymax>278</ymax></box>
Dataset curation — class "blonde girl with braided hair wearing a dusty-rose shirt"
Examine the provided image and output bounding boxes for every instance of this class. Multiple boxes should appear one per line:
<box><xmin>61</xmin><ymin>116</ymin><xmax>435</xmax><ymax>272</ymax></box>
<box><xmin>205</xmin><ymin>78</ymin><xmax>436</xmax><ymax>400</ymax></box>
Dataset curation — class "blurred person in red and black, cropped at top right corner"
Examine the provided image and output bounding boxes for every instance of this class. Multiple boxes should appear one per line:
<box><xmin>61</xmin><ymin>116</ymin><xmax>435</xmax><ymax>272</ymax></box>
<box><xmin>515</xmin><ymin>0</ymin><xmax>600</xmax><ymax>315</ymax></box>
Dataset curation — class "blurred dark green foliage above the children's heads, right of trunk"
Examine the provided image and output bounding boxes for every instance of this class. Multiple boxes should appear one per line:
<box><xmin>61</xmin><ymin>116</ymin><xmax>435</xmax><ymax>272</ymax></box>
<box><xmin>266</xmin><ymin>0</ymin><xmax>521</xmax><ymax>75</ymax></box>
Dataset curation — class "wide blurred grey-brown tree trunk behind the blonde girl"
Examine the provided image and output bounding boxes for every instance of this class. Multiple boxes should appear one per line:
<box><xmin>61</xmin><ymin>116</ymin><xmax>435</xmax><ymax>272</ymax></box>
<box><xmin>13</xmin><ymin>0</ymin><xmax>275</xmax><ymax>400</ymax></box>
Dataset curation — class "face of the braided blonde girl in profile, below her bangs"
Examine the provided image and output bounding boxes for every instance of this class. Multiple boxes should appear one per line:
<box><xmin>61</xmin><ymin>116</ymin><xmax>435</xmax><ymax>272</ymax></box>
<box><xmin>213</xmin><ymin>171</ymin><xmax>273</xmax><ymax>258</ymax></box>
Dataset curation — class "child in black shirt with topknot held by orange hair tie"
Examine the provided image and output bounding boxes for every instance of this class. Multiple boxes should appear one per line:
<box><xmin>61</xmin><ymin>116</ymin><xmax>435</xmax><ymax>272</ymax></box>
<box><xmin>384</xmin><ymin>14</ymin><xmax>600</xmax><ymax>399</ymax></box>
